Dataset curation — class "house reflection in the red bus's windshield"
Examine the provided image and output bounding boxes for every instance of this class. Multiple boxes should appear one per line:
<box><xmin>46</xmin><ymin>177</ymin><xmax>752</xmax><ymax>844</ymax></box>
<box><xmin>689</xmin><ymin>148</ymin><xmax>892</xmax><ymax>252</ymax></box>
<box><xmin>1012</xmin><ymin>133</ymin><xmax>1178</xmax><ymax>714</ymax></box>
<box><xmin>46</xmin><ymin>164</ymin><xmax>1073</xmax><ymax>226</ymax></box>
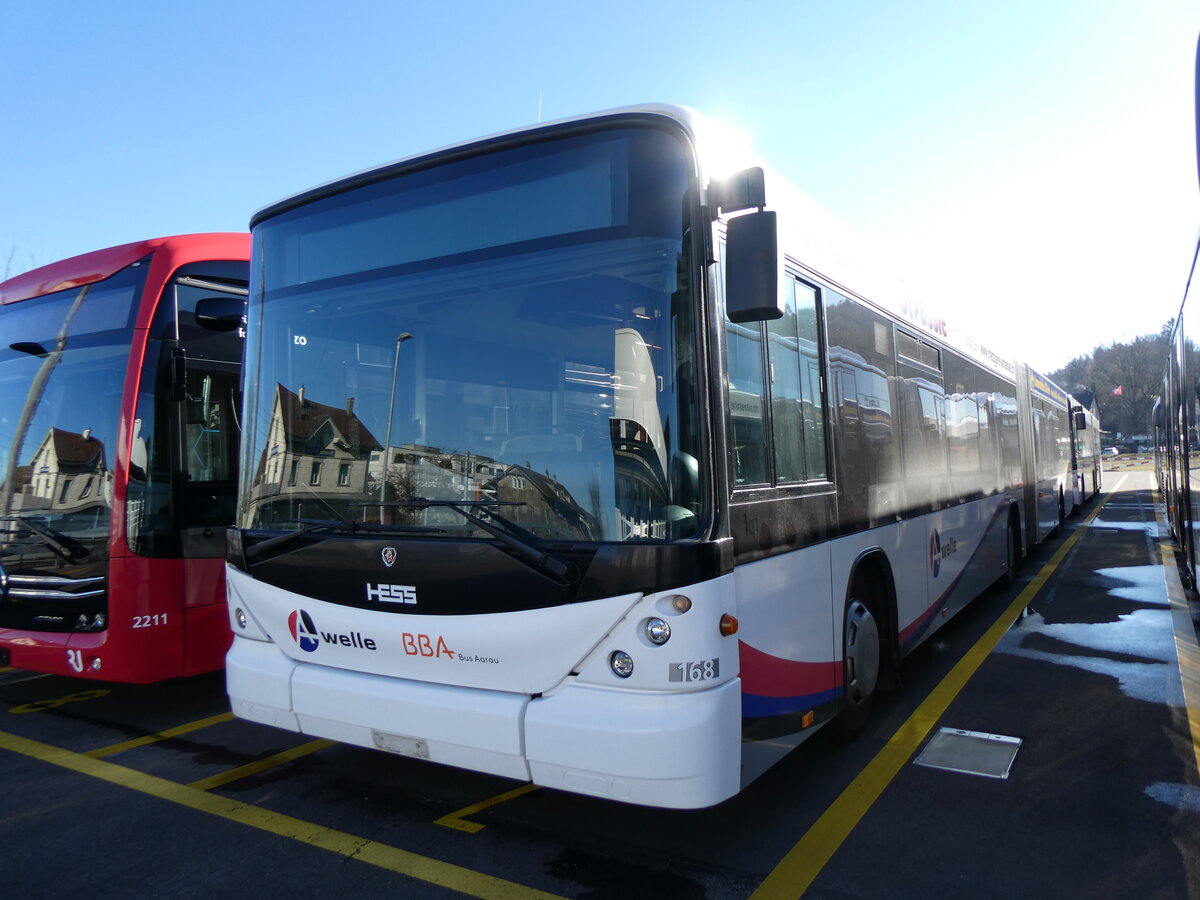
<box><xmin>13</xmin><ymin>428</ymin><xmax>113</xmax><ymax>512</ymax></box>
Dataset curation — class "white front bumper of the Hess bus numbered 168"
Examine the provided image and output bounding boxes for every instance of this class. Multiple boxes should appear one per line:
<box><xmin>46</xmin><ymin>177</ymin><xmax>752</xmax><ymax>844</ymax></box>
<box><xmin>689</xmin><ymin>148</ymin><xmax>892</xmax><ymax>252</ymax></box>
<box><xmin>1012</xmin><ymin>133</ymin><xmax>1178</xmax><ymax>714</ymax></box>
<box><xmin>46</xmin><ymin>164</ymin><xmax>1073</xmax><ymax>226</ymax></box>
<box><xmin>226</xmin><ymin>638</ymin><xmax>742</xmax><ymax>809</ymax></box>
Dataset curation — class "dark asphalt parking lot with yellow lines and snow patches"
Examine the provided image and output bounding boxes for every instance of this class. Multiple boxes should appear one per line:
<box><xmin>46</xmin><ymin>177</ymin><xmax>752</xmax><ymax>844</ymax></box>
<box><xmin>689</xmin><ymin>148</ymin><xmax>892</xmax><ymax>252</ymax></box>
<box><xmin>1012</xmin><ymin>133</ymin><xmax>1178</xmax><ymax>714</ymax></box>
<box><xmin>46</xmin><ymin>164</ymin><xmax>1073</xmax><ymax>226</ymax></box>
<box><xmin>0</xmin><ymin>470</ymin><xmax>1200</xmax><ymax>898</ymax></box>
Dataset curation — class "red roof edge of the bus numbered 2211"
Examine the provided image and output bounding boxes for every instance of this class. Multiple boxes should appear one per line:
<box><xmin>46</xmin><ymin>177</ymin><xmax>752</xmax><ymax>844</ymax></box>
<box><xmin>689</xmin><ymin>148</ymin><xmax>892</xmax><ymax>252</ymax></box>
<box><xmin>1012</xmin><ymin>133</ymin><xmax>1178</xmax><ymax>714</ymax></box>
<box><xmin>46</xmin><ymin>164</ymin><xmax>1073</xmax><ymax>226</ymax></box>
<box><xmin>0</xmin><ymin>233</ymin><xmax>250</xmax><ymax>304</ymax></box>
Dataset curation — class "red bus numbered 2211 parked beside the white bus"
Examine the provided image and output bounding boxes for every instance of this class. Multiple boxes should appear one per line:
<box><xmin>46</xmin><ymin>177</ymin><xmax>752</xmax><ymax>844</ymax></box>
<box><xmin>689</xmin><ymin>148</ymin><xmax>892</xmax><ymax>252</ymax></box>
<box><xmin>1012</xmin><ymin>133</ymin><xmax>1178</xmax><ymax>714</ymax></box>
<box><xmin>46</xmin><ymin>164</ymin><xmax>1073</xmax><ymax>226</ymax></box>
<box><xmin>0</xmin><ymin>234</ymin><xmax>250</xmax><ymax>683</ymax></box>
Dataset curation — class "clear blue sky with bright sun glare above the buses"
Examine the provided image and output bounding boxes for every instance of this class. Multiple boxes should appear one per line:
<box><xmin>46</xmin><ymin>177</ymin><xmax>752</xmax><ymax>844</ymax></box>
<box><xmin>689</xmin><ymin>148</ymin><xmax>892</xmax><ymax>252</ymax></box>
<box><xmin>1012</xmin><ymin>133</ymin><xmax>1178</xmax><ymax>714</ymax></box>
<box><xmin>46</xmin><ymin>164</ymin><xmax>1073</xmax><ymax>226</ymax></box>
<box><xmin>0</xmin><ymin>0</ymin><xmax>1200</xmax><ymax>371</ymax></box>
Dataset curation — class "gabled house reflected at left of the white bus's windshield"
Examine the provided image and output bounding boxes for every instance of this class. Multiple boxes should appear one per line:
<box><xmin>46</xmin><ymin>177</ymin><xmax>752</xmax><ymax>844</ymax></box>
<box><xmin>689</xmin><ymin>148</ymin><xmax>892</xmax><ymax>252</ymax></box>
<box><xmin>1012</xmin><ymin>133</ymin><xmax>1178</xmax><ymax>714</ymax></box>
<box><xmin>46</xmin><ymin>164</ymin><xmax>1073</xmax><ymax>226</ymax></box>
<box><xmin>252</xmin><ymin>385</ymin><xmax>382</xmax><ymax>517</ymax></box>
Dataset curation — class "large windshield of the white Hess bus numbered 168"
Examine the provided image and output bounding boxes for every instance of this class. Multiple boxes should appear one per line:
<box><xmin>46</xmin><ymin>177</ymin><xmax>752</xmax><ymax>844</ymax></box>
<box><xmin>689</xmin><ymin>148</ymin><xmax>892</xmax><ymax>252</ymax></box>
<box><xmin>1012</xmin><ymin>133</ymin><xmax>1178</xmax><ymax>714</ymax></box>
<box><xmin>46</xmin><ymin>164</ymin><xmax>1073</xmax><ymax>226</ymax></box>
<box><xmin>240</xmin><ymin>127</ymin><xmax>703</xmax><ymax>541</ymax></box>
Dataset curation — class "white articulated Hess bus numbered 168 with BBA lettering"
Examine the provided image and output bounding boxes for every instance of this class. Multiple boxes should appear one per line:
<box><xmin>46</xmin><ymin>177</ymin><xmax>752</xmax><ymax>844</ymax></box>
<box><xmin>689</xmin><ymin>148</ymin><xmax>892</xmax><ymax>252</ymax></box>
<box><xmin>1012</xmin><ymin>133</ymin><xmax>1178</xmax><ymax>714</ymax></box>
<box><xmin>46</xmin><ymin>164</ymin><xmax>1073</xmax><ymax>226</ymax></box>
<box><xmin>227</xmin><ymin>106</ymin><xmax>1099</xmax><ymax>808</ymax></box>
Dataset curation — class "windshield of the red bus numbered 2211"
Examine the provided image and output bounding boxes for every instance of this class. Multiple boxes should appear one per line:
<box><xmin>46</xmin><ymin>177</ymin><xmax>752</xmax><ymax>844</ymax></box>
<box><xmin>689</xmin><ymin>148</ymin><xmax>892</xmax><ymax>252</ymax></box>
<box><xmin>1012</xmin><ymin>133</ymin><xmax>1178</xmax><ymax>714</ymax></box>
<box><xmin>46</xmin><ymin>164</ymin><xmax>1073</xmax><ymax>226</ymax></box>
<box><xmin>0</xmin><ymin>266</ymin><xmax>146</xmax><ymax>542</ymax></box>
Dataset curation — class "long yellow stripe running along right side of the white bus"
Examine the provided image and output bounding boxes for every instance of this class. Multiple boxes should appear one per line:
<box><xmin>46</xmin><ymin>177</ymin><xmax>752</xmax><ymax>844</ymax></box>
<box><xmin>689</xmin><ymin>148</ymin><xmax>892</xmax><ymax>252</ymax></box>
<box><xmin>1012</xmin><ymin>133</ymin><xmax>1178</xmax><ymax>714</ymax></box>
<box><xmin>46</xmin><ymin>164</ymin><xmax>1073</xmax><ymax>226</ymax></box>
<box><xmin>750</xmin><ymin>475</ymin><xmax>1128</xmax><ymax>900</ymax></box>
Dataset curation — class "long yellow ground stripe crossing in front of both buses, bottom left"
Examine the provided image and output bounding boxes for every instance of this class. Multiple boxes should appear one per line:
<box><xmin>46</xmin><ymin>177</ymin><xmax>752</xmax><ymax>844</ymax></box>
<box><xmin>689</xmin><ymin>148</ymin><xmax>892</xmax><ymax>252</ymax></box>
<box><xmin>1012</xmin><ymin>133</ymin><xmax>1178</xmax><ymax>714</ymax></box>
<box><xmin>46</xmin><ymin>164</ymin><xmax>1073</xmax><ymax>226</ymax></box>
<box><xmin>0</xmin><ymin>731</ymin><xmax>559</xmax><ymax>900</ymax></box>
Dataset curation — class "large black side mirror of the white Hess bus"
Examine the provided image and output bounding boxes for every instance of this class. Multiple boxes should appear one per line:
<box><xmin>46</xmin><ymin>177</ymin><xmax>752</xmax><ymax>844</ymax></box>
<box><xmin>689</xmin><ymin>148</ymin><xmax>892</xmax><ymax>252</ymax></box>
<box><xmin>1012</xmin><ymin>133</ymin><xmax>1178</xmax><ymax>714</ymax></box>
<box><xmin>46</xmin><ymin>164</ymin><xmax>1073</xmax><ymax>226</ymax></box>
<box><xmin>725</xmin><ymin>210</ymin><xmax>784</xmax><ymax>322</ymax></box>
